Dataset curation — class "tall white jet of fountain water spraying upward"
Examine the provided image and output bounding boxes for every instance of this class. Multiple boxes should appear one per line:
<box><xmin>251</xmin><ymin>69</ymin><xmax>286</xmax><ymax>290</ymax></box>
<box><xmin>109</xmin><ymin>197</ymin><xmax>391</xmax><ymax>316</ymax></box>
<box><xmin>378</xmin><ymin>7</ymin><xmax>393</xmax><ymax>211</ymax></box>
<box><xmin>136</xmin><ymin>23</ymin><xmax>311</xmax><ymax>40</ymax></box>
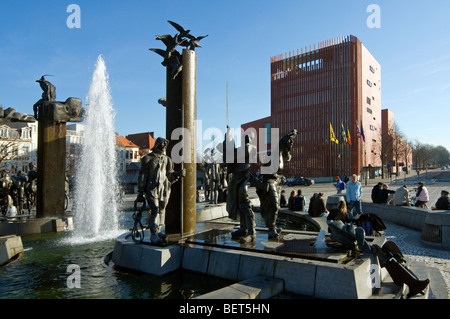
<box><xmin>70</xmin><ymin>55</ymin><xmax>119</xmax><ymax>243</ymax></box>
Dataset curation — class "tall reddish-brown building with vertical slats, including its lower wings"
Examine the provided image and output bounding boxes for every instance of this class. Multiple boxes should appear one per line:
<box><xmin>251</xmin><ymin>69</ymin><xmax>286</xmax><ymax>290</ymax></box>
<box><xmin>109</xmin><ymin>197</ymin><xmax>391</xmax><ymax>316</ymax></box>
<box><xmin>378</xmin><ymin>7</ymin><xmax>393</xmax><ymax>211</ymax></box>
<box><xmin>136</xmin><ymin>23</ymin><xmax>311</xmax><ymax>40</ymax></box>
<box><xmin>241</xmin><ymin>35</ymin><xmax>412</xmax><ymax>181</ymax></box>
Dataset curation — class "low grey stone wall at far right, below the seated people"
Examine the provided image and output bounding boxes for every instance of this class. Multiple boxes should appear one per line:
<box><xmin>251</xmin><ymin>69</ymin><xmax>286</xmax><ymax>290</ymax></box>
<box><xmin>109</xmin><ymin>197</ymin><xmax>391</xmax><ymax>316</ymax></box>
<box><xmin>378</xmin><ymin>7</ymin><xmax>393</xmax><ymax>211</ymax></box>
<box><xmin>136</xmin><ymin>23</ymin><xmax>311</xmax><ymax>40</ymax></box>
<box><xmin>362</xmin><ymin>202</ymin><xmax>450</xmax><ymax>249</ymax></box>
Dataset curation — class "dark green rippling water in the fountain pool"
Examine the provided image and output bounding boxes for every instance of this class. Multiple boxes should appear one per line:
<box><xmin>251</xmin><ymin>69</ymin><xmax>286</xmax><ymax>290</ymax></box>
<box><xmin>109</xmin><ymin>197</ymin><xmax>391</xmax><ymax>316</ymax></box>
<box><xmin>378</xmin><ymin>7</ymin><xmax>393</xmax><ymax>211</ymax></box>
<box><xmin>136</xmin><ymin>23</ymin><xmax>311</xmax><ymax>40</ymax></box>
<box><xmin>0</xmin><ymin>212</ymin><xmax>230</xmax><ymax>299</ymax></box>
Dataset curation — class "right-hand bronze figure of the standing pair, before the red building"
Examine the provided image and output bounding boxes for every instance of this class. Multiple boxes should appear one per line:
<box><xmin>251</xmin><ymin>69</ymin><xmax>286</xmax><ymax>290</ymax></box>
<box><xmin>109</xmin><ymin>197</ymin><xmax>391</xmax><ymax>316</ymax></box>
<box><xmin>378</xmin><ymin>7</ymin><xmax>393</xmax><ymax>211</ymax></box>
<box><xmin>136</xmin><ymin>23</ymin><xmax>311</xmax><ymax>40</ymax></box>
<box><xmin>256</xmin><ymin>130</ymin><xmax>297</xmax><ymax>238</ymax></box>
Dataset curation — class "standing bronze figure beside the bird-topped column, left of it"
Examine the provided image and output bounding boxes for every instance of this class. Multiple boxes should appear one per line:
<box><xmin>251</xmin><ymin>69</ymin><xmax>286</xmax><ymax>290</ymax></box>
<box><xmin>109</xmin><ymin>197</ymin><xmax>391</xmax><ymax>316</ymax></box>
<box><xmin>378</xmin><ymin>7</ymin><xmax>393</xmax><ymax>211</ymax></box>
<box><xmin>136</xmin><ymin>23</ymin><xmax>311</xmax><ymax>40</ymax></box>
<box><xmin>136</xmin><ymin>137</ymin><xmax>184</xmax><ymax>244</ymax></box>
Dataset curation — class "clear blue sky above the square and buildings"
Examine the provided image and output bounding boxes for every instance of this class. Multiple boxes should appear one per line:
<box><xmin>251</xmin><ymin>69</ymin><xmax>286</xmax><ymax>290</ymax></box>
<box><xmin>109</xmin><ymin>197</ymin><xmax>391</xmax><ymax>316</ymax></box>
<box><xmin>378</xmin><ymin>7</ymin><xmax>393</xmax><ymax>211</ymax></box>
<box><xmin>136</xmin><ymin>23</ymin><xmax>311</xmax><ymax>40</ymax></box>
<box><xmin>0</xmin><ymin>0</ymin><xmax>450</xmax><ymax>154</ymax></box>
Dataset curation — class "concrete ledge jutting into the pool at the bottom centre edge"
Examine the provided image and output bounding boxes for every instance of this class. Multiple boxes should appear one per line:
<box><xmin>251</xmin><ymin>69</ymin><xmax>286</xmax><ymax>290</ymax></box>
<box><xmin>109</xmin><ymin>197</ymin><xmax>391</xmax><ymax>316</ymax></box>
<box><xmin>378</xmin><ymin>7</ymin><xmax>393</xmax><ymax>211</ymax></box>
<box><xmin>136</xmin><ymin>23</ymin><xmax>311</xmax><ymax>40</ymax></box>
<box><xmin>194</xmin><ymin>276</ymin><xmax>283</xmax><ymax>299</ymax></box>
